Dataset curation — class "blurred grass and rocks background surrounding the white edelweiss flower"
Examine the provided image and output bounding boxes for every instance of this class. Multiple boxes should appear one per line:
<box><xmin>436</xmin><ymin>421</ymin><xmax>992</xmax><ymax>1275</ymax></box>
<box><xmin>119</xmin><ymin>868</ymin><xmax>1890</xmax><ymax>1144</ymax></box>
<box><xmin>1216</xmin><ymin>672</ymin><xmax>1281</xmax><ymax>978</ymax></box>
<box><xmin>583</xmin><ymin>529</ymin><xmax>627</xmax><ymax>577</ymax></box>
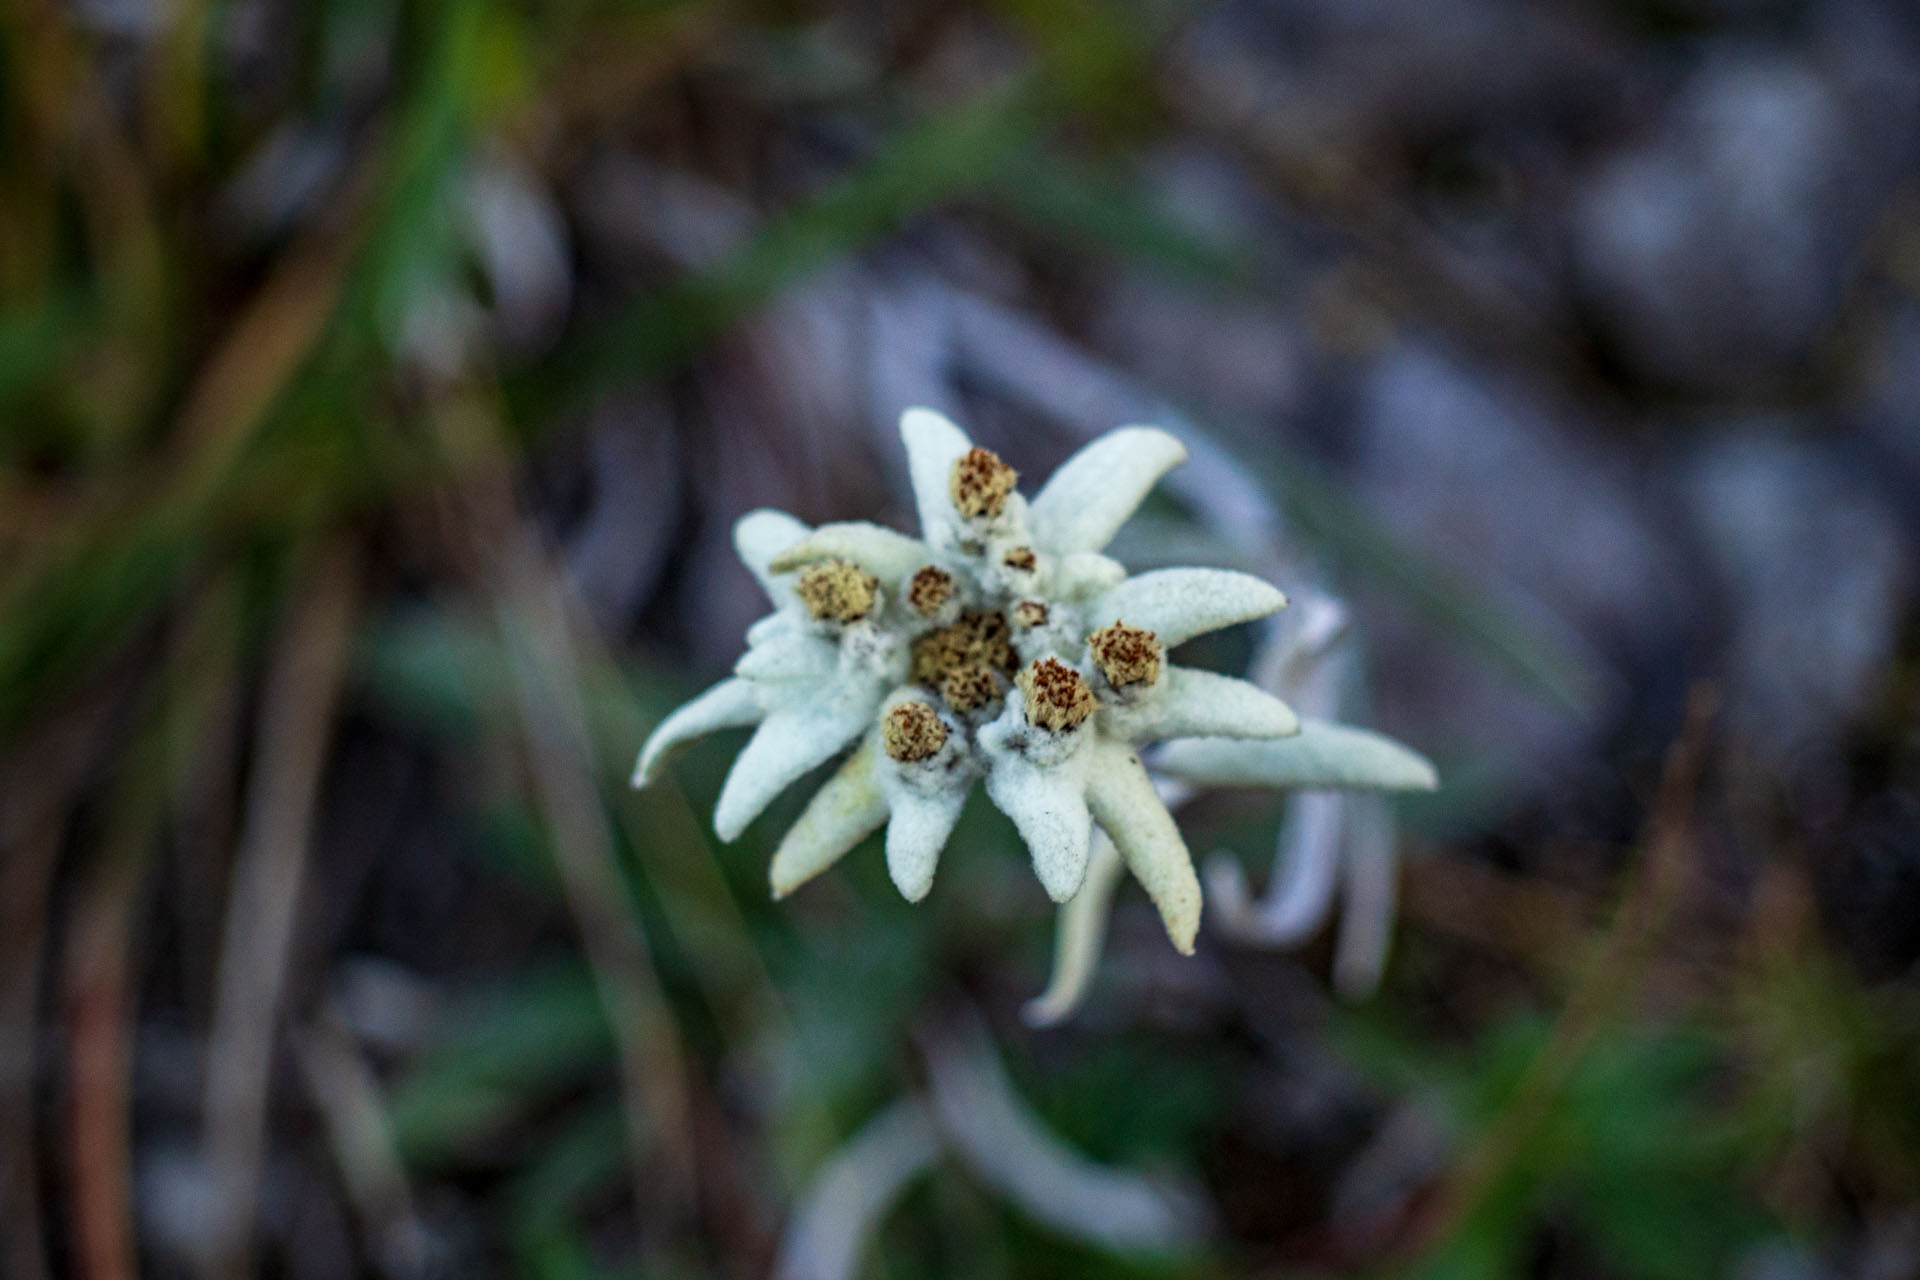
<box><xmin>0</xmin><ymin>0</ymin><xmax>1920</xmax><ymax>1280</ymax></box>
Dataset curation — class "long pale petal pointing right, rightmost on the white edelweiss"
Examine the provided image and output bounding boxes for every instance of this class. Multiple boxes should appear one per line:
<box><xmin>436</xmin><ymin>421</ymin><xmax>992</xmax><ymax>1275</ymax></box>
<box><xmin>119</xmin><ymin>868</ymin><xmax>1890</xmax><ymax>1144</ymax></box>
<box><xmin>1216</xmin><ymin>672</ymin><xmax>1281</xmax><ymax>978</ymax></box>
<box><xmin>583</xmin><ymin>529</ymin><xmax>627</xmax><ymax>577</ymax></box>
<box><xmin>1154</xmin><ymin>720</ymin><xmax>1438</xmax><ymax>791</ymax></box>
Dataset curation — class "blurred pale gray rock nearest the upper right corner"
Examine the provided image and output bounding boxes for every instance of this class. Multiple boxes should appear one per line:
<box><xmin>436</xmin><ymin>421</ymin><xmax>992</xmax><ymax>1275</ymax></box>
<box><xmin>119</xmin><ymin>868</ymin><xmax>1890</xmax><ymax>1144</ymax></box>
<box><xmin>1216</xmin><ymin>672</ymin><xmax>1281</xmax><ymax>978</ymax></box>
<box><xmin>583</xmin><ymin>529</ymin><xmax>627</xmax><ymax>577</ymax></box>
<box><xmin>1571</xmin><ymin>54</ymin><xmax>1874</xmax><ymax>390</ymax></box>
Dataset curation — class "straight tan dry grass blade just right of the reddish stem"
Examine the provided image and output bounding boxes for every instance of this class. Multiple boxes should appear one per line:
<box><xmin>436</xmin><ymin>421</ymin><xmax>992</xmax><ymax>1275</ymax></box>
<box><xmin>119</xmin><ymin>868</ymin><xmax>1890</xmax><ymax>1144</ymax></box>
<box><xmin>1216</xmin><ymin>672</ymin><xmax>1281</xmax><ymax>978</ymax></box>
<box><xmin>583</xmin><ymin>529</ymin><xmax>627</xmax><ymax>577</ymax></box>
<box><xmin>202</xmin><ymin>547</ymin><xmax>357</xmax><ymax>1280</ymax></box>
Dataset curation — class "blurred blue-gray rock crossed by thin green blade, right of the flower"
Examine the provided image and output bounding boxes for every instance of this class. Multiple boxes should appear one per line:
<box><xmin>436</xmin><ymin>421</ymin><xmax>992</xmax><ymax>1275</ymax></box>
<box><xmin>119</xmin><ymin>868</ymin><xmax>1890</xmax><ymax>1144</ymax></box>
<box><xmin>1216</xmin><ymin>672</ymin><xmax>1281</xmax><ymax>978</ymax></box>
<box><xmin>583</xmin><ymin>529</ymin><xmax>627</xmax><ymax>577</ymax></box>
<box><xmin>1352</xmin><ymin>344</ymin><xmax>1674</xmax><ymax>785</ymax></box>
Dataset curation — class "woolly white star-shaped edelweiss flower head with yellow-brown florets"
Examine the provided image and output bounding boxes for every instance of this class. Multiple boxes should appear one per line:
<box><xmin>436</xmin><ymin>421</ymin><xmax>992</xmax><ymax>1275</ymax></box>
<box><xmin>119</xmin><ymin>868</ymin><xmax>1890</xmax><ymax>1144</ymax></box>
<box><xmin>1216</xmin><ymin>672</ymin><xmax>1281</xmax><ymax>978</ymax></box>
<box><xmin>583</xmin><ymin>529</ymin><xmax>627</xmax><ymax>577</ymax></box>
<box><xmin>634</xmin><ymin>409</ymin><xmax>1300</xmax><ymax>952</ymax></box>
